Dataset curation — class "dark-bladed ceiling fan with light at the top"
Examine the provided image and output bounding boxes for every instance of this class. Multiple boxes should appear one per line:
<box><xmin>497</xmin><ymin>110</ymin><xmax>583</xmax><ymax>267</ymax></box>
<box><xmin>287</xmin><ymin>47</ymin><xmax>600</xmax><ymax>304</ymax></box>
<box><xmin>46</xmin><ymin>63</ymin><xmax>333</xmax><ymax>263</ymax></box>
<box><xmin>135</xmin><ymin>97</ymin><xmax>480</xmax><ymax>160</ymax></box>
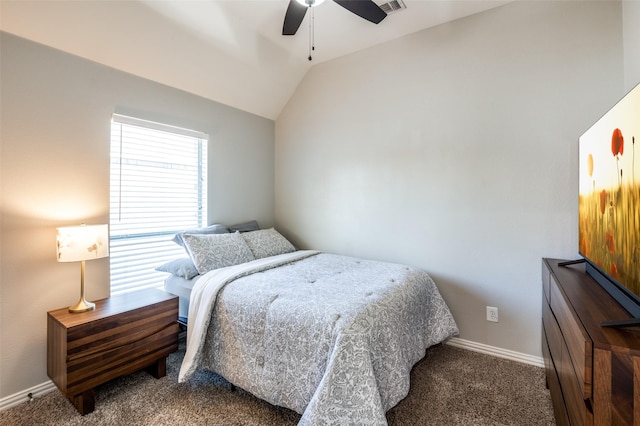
<box><xmin>282</xmin><ymin>0</ymin><xmax>387</xmax><ymax>35</ymax></box>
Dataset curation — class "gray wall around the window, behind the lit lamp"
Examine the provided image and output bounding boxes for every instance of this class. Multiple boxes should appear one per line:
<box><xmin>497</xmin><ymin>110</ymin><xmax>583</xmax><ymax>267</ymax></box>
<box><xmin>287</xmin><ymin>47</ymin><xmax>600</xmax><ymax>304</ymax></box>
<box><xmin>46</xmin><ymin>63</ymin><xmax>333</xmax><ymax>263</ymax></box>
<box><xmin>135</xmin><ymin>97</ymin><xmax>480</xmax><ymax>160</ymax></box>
<box><xmin>0</xmin><ymin>33</ymin><xmax>274</xmax><ymax>398</ymax></box>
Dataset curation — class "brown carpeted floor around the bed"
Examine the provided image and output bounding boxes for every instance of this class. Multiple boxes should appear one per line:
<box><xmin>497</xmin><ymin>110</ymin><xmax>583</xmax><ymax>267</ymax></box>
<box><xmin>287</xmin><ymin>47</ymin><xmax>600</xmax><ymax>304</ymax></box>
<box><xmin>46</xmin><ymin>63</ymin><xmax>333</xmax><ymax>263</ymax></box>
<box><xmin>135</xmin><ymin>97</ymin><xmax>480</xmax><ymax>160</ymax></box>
<box><xmin>0</xmin><ymin>345</ymin><xmax>555</xmax><ymax>426</ymax></box>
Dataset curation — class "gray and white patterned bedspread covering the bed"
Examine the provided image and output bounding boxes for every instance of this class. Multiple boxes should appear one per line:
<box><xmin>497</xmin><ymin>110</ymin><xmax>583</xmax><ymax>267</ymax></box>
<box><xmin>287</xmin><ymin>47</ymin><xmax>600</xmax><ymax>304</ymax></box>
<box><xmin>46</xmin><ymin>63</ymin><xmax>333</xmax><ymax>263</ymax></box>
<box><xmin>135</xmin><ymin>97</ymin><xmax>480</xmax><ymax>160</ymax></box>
<box><xmin>179</xmin><ymin>250</ymin><xmax>458</xmax><ymax>425</ymax></box>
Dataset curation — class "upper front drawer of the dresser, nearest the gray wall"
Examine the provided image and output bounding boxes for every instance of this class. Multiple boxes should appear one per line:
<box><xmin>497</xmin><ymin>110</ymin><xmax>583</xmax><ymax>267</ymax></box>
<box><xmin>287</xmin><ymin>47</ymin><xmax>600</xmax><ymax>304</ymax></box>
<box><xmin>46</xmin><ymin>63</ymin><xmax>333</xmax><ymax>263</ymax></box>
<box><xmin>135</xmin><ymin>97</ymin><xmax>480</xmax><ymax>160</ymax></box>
<box><xmin>549</xmin><ymin>275</ymin><xmax>592</xmax><ymax>400</ymax></box>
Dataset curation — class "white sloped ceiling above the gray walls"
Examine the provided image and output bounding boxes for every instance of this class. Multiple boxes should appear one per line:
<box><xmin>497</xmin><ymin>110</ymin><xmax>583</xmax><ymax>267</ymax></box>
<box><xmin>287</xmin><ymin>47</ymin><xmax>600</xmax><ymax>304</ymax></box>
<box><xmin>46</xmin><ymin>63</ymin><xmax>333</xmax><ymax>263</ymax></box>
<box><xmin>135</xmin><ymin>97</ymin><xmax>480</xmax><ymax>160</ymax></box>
<box><xmin>0</xmin><ymin>0</ymin><xmax>508</xmax><ymax>119</ymax></box>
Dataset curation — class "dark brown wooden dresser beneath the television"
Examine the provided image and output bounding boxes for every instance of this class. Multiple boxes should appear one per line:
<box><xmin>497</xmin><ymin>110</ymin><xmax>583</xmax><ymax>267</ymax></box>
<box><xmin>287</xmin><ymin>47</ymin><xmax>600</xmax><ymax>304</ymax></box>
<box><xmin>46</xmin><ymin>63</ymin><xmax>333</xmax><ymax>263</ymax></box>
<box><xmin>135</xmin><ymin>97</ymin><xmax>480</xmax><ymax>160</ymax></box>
<box><xmin>542</xmin><ymin>259</ymin><xmax>640</xmax><ymax>426</ymax></box>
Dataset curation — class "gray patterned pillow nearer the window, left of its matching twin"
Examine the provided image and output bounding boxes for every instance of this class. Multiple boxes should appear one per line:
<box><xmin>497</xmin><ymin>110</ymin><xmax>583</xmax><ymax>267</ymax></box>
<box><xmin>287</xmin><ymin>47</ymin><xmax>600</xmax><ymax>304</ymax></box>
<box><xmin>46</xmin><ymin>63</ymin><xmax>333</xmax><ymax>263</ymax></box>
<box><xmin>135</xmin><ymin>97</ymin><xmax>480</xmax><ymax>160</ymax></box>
<box><xmin>182</xmin><ymin>232</ymin><xmax>255</xmax><ymax>274</ymax></box>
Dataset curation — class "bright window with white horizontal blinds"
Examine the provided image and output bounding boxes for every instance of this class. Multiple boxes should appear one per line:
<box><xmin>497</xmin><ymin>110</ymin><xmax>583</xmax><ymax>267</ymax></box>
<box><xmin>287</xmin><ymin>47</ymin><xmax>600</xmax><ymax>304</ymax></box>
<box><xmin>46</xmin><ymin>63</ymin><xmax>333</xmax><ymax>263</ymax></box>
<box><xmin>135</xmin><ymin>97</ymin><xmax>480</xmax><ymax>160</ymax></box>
<box><xmin>109</xmin><ymin>114</ymin><xmax>208</xmax><ymax>295</ymax></box>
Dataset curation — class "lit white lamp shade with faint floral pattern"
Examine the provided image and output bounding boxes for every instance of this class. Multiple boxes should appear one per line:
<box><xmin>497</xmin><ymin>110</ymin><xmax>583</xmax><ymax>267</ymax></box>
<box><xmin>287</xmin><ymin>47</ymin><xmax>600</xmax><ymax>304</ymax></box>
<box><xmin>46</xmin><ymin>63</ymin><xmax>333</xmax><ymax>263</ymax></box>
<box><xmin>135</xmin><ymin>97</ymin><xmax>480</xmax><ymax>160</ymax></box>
<box><xmin>56</xmin><ymin>224</ymin><xmax>109</xmax><ymax>262</ymax></box>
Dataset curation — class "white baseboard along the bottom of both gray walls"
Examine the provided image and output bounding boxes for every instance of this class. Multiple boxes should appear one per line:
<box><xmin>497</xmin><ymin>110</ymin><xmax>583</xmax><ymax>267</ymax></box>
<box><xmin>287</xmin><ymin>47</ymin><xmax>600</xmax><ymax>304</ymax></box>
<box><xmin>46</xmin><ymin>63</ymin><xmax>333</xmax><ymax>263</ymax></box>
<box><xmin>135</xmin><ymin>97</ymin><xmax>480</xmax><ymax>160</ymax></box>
<box><xmin>0</xmin><ymin>337</ymin><xmax>544</xmax><ymax>411</ymax></box>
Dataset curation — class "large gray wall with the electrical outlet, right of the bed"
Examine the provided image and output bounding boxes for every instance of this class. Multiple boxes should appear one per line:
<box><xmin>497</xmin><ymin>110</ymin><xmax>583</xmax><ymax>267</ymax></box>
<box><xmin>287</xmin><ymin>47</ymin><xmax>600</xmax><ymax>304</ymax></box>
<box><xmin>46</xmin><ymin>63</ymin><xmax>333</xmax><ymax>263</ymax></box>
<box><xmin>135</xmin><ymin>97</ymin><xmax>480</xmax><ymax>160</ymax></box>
<box><xmin>275</xmin><ymin>1</ymin><xmax>625</xmax><ymax>356</ymax></box>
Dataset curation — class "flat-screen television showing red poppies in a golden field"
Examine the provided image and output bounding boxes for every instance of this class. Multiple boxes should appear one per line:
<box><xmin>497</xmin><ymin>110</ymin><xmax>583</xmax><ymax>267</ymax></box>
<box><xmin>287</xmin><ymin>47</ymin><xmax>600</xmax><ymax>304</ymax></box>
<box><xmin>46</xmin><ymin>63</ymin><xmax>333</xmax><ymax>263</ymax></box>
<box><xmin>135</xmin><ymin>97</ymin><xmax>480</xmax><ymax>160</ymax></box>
<box><xmin>578</xmin><ymin>84</ymin><xmax>640</xmax><ymax>327</ymax></box>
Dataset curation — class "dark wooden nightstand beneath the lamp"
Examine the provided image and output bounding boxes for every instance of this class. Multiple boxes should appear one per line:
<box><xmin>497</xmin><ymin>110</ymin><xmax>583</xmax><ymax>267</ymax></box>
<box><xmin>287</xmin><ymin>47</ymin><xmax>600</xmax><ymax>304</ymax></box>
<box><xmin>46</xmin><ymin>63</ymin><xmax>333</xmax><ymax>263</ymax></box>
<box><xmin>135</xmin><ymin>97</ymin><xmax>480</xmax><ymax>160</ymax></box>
<box><xmin>47</xmin><ymin>289</ymin><xmax>178</xmax><ymax>415</ymax></box>
